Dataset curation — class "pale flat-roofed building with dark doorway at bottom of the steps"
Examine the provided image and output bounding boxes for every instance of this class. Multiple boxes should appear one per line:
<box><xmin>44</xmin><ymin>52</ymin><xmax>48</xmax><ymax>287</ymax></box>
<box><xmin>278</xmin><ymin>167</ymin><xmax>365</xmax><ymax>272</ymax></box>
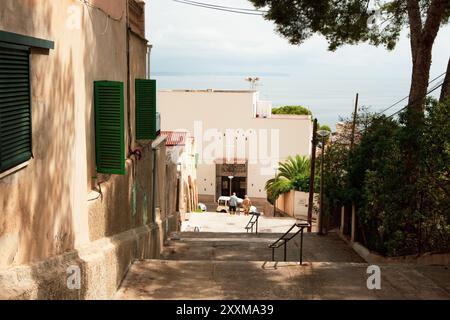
<box><xmin>157</xmin><ymin>89</ymin><xmax>312</xmax><ymax>210</ymax></box>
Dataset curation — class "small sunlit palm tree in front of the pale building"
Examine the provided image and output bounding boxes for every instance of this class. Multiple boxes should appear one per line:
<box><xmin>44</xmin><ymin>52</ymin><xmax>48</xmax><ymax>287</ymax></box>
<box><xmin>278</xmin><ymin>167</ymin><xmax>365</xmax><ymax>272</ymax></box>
<box><xmin>265</xmin><ymin>155</ymin><xmax>310</xmax><ymax>203</ymax></box>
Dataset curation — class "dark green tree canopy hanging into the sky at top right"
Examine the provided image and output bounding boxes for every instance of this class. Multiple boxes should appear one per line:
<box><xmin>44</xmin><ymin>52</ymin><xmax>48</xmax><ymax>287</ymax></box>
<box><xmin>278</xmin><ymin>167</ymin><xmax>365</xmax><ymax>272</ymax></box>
<box><xmin>250</xmin><ymin>0</ymin><xmax>450</xmax><ymax>51</ymax></box>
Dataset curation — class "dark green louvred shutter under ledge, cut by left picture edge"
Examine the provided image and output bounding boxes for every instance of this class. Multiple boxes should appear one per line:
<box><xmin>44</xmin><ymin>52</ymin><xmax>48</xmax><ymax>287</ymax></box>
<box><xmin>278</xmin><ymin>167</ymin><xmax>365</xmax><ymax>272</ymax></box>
<box><xmin>0</xmin><ymin>43</ymin><xmax>32</xmax><ymax>172</ymax></box>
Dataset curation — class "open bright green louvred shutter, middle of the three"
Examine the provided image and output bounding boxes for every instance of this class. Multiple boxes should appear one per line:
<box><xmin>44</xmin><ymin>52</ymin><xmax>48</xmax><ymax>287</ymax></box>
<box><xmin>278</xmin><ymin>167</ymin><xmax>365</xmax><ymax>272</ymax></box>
<box><xmin>94</xmin><ymin>81</ymin><xmax>125</xmax><ymax>174</ymax></box>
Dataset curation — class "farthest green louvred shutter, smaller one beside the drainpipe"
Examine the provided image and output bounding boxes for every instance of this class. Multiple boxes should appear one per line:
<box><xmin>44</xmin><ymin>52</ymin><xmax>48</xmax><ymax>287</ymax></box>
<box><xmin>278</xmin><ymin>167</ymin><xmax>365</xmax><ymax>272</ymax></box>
<box><xmin>135</xmin><ymin>79</ymin><xmax>156</xmax><ymax>140</ymax></box>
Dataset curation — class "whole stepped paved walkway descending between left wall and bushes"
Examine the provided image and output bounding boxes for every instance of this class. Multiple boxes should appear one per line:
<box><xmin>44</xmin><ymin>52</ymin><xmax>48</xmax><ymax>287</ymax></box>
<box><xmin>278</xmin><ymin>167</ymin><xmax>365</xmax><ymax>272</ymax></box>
<box><xmin>115</xmin><ymin>213</ymin><xmax>450</xmax><ymax>300</ymax></box>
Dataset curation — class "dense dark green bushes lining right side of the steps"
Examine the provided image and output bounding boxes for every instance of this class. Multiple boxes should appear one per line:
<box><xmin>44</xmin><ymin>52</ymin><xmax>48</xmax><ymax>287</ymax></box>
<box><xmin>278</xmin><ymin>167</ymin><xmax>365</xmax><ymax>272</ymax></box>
<box><xmin>324</xmin><ymin>99</ymin><xmax>450</xmax><ymax>256</ymax></box>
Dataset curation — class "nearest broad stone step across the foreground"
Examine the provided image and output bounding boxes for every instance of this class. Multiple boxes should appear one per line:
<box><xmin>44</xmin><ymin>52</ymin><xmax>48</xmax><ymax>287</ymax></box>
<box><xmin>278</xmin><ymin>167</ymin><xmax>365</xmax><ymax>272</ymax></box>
<box><xmin>115</xmin><ymin>260</ymin><xmax>450</xmax><ymax>300</ymax></box>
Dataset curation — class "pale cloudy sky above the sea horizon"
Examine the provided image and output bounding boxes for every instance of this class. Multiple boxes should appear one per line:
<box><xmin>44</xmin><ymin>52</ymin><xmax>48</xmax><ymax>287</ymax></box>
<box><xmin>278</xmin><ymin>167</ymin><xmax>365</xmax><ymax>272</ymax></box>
<box><xmin>146</xmin><ymin>0</ymin><xmax>450</xmax><ymax>126</ymax></box>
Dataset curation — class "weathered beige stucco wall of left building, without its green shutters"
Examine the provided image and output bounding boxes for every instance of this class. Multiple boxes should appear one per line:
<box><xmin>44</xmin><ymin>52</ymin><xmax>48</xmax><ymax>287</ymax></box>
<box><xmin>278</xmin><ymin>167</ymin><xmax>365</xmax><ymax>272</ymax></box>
<box><xmin>0</xmin><ymin>0</ymin><xmax>183</xmax><ymax>298</ymax></box>
